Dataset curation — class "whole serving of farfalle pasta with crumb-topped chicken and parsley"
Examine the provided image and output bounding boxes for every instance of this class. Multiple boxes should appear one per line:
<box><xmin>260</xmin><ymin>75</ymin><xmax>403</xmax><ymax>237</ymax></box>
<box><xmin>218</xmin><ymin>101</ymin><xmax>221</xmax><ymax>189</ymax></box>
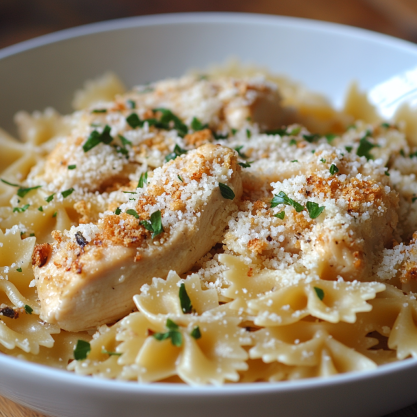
<box><xmin>0</xmin><ymin>64</ymin><xmax>417</xmax><ymax>385</ymax></box>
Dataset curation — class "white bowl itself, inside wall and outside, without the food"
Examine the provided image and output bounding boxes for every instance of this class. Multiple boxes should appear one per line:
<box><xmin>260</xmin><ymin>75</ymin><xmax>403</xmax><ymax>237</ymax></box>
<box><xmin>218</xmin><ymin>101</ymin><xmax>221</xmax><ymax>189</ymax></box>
<box><xmin>0</xmin><ymin>13</ymin><xmax>417</xmax><ymax>417</ymax></box>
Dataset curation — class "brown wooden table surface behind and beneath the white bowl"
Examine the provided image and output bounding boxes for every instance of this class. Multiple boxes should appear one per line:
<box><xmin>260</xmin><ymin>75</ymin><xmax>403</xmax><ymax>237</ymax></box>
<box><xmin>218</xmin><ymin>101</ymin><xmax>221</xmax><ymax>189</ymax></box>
<box><xmin>0</xmin><ymin>0</ymin><xmax>417</xmax><ymax>417</ymax></box>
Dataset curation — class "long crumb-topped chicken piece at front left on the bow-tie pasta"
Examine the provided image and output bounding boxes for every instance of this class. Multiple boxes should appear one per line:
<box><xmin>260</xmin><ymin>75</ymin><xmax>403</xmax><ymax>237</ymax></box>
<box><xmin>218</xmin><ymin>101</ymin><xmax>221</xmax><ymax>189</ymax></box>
<box><xmin>33</xmin><ymin>144</ymin><xmax>242</xmax><ymax>331</ymax></box>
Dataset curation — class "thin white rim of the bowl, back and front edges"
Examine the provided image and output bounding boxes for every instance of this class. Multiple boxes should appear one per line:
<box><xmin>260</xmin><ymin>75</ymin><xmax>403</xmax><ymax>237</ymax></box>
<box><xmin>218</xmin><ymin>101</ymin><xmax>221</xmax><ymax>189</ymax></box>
<box><xmin>0</xmin><ymin>12</ymin><xmax>417</xmax><ymax>396</ymax></box>
